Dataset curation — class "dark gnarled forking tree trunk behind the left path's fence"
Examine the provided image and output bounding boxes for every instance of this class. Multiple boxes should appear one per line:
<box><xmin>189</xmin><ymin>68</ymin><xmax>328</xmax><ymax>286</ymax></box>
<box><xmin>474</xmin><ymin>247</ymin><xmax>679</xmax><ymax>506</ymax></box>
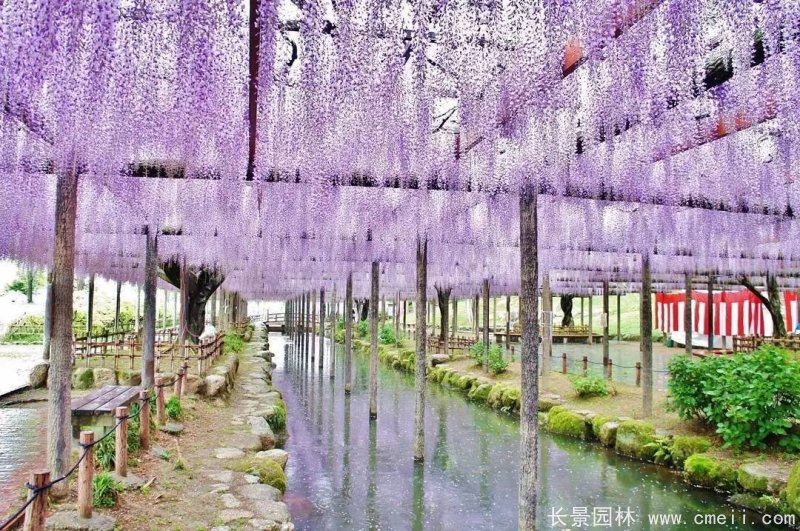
<box><xmin>160</xmin><ymin>259</ymin><xmax>222</xmax><ymax>342</ymax></box>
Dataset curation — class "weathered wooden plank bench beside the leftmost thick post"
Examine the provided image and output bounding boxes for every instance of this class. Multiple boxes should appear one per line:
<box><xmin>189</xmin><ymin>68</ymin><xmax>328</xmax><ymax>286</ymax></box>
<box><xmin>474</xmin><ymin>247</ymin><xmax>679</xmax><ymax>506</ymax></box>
<box><xmin>71</xmin><ymin>385</ymin><xmax>141</xmax><ymax>440</ymax></box>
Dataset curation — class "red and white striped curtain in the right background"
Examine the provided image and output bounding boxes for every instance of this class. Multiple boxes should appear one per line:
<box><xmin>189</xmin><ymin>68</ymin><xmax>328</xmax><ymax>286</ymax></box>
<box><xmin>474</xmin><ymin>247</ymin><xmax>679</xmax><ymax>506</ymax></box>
<box><xmin>655</xmin><ymin>290</ymin><xmax>800</xmax><ymax>336</ymax></box>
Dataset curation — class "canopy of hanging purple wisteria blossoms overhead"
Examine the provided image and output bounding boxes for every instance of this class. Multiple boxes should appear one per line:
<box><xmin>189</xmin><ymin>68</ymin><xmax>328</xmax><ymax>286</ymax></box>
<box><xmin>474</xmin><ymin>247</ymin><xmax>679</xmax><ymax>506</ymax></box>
<box><xmin>0</xmin><ymin>0</ymin><xmax>800</xmax><ymax>298</ymax></box>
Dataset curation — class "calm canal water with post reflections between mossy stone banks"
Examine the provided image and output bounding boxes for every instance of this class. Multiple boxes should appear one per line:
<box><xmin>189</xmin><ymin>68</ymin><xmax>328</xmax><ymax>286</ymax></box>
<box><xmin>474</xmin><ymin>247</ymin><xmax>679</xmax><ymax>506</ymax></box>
<box><xmin>270</xmin><ymin>334</ymin><xmax>780</xmax><ymax>530</ymax></box>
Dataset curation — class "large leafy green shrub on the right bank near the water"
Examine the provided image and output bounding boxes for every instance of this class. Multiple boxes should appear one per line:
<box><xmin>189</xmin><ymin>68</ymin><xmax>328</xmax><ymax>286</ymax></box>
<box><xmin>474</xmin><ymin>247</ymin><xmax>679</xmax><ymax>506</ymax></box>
<box><xmin>668</xmin><ymin>346</ymin><xmax>800</xmax><ymax>451</ymax></box>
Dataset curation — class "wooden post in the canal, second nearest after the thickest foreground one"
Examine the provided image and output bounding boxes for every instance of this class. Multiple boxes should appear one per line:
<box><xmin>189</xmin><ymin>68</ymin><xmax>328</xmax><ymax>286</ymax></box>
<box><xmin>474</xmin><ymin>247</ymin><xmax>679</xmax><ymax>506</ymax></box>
<box><xmin>414</xmin><ymin>236</ymin><xmax>428</xmax><ymax>461</ymax></box>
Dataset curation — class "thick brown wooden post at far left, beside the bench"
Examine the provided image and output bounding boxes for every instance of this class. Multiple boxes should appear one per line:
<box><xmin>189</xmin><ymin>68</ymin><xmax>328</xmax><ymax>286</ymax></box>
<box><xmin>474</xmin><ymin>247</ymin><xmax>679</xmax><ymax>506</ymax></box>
<box><xmin>47</xmin><ymin>168</ymin><xmax>78</xmax><ymax>495</ymax></box>
